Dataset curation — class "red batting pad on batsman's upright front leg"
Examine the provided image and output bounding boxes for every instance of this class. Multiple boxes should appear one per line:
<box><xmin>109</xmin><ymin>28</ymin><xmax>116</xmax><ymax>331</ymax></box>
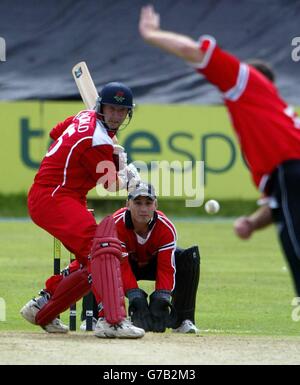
<box><xmin>91</xmin><ymin>216</ymin><xmax>126</xmax><ymax>324</ymax></box>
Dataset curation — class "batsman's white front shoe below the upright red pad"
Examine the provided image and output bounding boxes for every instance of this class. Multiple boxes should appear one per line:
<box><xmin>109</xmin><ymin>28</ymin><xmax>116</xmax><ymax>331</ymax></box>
<box><xmin>95</xmin><ymin>318</ymin><xmax>145</xmax><ymax>338</ymax></box>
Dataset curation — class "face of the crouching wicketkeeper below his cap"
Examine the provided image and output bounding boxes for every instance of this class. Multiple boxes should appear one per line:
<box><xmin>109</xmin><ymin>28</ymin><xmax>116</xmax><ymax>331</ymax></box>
<box><xmin>128</xmin><ymin>196</ymin><xmax>157</xmax><ymax>224</ymax></box>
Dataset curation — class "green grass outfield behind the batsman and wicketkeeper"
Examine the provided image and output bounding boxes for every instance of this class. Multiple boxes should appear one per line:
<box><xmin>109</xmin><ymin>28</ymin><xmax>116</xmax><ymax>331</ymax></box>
<box><xmin>0</xmin><ymin>220</ymin><xmax>300</xmax><ymax>336</ymax></box>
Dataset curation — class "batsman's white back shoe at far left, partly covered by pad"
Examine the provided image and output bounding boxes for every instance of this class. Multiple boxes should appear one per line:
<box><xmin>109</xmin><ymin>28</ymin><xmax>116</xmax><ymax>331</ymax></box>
<box><xmin>20</xmin><ymin>296</ymin><xmax>69</xmax><ymax>333</ymax></box>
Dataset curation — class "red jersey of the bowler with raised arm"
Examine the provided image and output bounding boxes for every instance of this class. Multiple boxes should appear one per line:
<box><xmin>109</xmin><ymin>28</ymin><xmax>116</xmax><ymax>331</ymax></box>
<box><xmin>191</xmin><ymin>36</ymin><xmax>300</xmax><ymax>189</ymax></box>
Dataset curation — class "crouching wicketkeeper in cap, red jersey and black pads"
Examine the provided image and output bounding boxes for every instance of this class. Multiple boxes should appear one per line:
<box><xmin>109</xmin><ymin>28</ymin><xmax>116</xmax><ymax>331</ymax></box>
<box><xmin>113</xmin><ymin>182</ymin><xmax>200</xmax><ymax>333</ymax></box>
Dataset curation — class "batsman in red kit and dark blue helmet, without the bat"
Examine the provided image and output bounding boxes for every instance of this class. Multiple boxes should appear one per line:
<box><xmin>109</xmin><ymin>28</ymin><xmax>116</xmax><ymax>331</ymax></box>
<box><xmin>21</xmin><ymin>82</ymin><xmax>145</xmax><ymax>338</ymax></box>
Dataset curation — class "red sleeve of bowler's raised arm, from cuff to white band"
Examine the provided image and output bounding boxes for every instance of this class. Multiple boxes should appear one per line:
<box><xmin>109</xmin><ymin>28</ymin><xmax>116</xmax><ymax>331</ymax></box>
<box><xmin>196</xmin><ymin>36</ymin><xmax>240</xmax><ymax>92</ymax></box>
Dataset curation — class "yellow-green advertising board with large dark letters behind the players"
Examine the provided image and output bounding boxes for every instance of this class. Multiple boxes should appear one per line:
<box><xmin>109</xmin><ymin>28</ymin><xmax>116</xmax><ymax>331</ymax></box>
<box><xmin>0</xmin><ymin>101</ymin><xmax>292</xmax><ymax>199</ymax></box>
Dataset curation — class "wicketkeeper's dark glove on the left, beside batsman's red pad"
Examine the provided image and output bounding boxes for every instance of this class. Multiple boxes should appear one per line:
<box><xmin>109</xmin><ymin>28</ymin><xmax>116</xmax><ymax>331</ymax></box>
<box><xmin>126</xmin><ymin>289</ymin><xmax>152</xmax><ymax>332</ymax></box>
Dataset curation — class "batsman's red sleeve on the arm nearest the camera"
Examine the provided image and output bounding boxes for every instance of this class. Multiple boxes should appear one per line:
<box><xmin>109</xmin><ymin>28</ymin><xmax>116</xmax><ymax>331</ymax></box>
<box><xmin>80</xmin><ymin>145</ymin><xmax>118</xmax><ymax>188</ymax></box>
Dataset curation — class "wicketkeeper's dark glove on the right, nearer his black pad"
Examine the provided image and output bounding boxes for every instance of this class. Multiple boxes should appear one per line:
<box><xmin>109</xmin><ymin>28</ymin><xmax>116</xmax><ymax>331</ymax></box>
<box><xmin>149</xmin><ymin>290</ymin><xmax>176</xmax><ymax>333</ymax></box>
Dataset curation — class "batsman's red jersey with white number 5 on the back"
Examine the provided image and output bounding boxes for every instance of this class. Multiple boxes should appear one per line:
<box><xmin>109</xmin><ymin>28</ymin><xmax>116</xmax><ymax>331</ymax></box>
<box><xmin>35</xmin><ymin>110</ymin><xmax>117</xmax><ymax>197</ymax></box>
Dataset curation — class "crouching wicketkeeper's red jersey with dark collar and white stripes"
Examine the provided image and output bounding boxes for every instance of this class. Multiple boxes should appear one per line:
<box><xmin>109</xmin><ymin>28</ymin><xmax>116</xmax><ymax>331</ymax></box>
<box><xmin>113</xmin><ymin>208</ymin><xmax>177</xmax><ymax>293</ymax></box>
